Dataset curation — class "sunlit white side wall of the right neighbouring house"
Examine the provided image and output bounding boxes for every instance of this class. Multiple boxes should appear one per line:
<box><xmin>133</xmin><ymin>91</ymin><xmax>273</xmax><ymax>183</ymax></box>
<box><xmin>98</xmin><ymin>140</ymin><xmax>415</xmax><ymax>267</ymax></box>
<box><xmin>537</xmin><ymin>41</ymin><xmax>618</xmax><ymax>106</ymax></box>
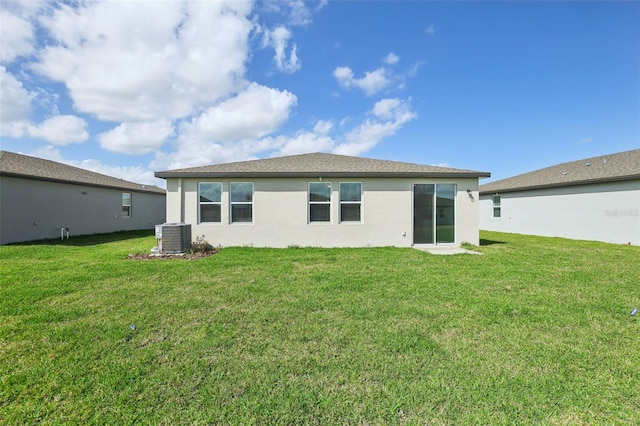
<box><xmin>480</xmin><ymin>180</ymin><xmax>640</xmax><ymax>245</ymax></box>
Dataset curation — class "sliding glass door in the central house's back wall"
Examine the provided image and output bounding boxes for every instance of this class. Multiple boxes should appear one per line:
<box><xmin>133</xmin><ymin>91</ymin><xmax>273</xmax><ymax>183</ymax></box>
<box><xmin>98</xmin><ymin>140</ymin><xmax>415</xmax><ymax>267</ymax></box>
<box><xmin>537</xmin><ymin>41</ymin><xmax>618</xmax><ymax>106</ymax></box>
<box><xmin>413</xmin><ymin>183</ymin><xmax>456</xmax><ymax>244</ymax></box>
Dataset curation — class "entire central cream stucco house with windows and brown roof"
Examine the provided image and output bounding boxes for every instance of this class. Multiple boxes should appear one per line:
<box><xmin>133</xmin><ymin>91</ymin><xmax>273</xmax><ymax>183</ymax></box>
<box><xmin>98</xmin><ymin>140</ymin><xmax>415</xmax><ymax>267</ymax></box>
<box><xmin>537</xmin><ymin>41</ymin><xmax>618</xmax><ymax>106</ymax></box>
<box><xmin>156</xmin><ymin>153</ymin><xmax>489</xmax><ymax>247</ymax></box>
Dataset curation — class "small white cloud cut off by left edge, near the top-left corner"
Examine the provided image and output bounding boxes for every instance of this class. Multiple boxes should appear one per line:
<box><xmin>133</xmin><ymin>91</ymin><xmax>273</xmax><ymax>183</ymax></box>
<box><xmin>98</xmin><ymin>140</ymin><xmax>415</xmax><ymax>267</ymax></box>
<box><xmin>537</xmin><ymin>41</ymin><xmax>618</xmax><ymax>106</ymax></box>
<box><xmin>0</xmin><ymin>6</ymin><xmax>33</xmax><ymax>62</ymax></box>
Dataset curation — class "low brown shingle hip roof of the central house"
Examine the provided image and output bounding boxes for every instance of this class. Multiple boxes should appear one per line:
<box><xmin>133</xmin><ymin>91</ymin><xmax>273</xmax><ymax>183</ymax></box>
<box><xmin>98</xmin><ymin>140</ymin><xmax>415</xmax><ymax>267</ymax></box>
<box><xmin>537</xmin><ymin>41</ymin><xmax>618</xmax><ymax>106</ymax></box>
<box><xmin>156</xmin><ymin>152</ymin><xmax>491</xmax><ymax>178</ymax></box>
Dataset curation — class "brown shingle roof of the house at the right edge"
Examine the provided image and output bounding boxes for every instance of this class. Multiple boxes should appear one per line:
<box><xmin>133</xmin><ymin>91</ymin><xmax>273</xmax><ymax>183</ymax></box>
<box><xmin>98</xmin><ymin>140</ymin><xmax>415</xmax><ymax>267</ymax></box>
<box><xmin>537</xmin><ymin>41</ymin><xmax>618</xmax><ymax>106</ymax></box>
<box><xmin>480</xmin><ymin>149</ymin><xmax>640</xmax><ymax>194</ymax></box>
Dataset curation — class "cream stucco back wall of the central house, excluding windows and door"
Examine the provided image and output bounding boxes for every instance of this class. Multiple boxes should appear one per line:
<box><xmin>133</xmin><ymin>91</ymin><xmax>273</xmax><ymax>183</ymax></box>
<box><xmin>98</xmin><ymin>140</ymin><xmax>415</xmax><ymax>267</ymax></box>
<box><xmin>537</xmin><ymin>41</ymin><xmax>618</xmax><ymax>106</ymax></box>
<box><xmin>167</xmin><ymin>178</ymin><xmax>479</xmax><ymax>247</ymax></box>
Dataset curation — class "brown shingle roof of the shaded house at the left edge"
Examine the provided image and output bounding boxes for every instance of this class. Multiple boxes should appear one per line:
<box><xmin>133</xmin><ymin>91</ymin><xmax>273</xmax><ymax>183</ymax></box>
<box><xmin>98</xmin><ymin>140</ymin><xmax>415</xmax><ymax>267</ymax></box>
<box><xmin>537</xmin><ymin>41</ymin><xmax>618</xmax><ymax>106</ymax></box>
<box><xmin>0</xmin><ymin>151</ymin><xmax>166</xmax><ymax>195</ymax></box>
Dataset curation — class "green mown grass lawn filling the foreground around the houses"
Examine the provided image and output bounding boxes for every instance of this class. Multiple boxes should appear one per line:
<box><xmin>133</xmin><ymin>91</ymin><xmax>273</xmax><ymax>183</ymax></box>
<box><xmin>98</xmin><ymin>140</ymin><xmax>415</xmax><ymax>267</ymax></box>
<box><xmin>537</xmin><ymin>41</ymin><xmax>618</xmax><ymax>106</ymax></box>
<box><xmin>0</xmin><ymin>232</ymin><xmax>640</xmax><ymax>425</ymax></box>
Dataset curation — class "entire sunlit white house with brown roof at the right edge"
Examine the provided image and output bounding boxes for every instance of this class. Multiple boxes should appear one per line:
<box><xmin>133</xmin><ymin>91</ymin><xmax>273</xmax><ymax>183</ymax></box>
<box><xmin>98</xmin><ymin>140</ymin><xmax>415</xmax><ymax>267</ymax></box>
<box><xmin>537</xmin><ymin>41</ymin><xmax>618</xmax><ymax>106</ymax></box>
<box><xmin>480</xmin><ymin>149</ymin><xmax>640</xmax><ymax>245</ymax></box>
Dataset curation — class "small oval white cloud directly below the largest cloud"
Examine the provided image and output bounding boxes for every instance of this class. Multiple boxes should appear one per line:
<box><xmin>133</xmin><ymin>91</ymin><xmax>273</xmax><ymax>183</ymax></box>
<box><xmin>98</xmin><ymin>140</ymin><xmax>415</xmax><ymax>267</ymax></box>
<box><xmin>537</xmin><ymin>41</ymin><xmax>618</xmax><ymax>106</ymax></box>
<box><xmin>98</xmin><ymin>120</ymin><xmax>174</xmax><ymax>154</ymax></box>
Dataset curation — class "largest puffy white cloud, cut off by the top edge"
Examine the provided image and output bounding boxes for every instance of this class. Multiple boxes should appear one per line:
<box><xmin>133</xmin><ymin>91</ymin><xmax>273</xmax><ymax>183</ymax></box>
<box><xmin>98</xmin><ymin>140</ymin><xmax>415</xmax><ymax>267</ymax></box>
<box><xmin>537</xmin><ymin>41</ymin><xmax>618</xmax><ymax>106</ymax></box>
<box><xmin>34</xmin><ymin>1</ymin><xmax>253</xmax><ymax>122</ymax></box>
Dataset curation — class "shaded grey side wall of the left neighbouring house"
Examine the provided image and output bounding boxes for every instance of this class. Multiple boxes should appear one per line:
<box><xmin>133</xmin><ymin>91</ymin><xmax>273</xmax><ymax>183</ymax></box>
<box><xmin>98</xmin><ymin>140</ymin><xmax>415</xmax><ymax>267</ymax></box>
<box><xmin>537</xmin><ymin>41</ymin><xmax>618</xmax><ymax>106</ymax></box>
<box><xmin>0</xmin><ymin>176</ymin><xmax>166</xmax><ymax>244</ymax></box>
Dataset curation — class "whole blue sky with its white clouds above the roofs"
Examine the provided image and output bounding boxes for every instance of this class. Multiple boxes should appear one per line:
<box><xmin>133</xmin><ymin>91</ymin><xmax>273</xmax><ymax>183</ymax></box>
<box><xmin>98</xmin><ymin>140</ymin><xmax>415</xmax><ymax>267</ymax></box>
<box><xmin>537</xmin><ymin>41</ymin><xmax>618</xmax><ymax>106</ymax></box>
<box><xmin>0</xmin><ymin>0</ymin><xmax>640</xmax><ymax>185</ymax></box>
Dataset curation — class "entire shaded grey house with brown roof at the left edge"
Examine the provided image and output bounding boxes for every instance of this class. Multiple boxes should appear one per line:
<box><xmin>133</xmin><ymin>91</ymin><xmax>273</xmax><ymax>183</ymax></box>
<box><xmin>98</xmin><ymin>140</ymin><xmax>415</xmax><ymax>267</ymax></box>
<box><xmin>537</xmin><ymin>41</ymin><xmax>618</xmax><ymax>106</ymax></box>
<box><xmin>0</xmin><ymin>151</ymin><xmax>166</xmax><ymax>244</ymax></box>
